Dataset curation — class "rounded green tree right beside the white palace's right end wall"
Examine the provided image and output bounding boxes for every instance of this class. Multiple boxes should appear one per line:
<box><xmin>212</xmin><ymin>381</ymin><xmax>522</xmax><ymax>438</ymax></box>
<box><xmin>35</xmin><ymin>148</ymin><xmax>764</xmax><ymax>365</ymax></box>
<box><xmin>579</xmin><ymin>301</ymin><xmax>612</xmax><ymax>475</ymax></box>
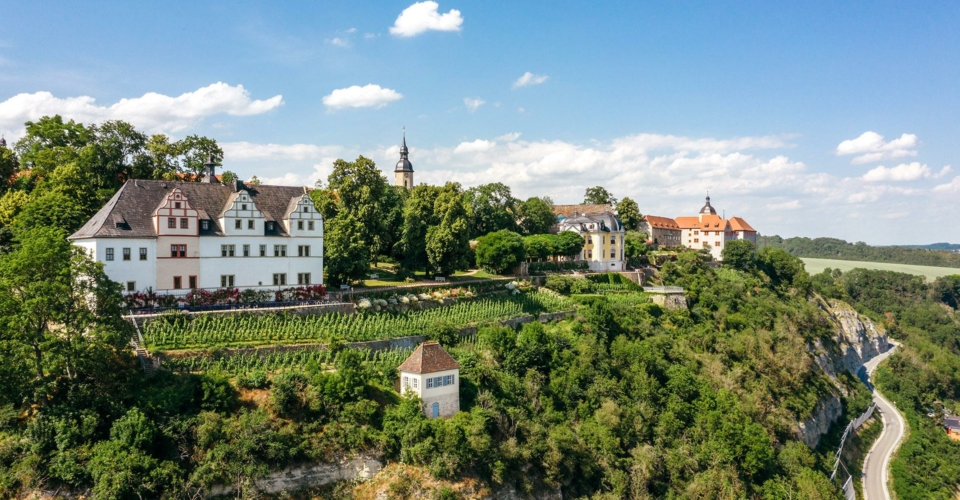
<box><xmin>324</xmin><ymin>211</ymin><xmax>370</xmax><ymax>285</ymax></box>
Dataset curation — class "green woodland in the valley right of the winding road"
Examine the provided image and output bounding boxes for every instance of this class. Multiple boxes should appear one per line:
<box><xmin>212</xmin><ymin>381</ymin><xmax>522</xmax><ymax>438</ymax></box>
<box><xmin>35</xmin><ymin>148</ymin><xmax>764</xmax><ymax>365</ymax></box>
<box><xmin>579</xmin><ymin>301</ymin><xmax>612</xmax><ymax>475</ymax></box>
<box><xmin>812</xmin><ymin>269</ymin><xmax>960</xmax><ymax>500</ymax></box>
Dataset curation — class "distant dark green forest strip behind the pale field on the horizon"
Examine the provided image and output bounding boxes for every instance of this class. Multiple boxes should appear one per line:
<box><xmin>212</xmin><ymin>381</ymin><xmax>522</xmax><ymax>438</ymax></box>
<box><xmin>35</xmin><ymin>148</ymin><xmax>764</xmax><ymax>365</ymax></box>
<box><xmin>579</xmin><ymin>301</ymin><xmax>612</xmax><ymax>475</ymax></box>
<box><xmin>757</xmin><ymin>236</ymin><xmax>960</xmax><ymax>268</ymax></box>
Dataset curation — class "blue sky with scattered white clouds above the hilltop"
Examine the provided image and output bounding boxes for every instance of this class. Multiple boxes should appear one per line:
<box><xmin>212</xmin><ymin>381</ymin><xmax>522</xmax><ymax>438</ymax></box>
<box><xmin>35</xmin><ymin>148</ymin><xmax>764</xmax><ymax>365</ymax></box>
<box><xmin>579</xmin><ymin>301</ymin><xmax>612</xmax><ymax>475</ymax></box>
<box><xmin>0</xmin><ymin>0</ymin><xmax>960</xmax><ymax>244</ymax></box>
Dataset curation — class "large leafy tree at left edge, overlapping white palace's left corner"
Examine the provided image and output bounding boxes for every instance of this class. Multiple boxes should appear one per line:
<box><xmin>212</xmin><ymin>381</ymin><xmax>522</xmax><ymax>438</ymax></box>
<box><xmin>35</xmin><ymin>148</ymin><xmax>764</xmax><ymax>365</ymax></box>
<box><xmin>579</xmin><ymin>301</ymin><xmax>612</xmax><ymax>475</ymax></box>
<box><xmin>0</xmin><ymin>227</ymin><xmax>130</xmax><ymax>403</ymax></box>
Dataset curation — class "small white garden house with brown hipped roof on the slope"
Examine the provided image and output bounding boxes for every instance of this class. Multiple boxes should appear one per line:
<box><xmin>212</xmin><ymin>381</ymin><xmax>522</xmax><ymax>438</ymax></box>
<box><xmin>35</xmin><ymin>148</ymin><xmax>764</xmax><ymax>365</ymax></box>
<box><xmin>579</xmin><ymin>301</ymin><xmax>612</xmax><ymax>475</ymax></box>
<box><xmin>397</xmin><ymin>342</ymin><xmax>460</xmax><ymax>418</ymax></box>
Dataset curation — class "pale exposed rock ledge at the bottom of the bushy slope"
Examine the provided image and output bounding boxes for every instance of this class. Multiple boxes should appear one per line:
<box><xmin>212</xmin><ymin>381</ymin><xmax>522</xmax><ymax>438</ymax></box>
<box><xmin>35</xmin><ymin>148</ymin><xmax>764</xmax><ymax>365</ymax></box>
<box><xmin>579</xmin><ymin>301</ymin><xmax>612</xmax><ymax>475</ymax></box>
<box><xmin>208</xmin><ymin>456</ymin><xmax>383</xmax><ymax>497</ymax></box>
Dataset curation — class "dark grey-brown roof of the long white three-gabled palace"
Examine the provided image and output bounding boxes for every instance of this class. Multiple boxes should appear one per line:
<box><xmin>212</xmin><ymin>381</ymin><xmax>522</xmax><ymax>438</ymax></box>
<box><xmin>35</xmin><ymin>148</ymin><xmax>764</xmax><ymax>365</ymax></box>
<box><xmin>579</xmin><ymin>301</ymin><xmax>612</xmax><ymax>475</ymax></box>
<box><xmin>70</xmin><ymin>179</ymin><xmax>306</xmax><ymax>240</ymax></box>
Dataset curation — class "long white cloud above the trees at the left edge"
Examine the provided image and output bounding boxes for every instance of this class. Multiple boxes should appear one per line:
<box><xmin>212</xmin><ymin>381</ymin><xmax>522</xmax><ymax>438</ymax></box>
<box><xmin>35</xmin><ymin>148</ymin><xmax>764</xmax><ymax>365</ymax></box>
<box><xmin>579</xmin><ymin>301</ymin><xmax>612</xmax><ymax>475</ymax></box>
<box><xmin>0</xmin><ymin>82</ymin><xmax>283</xmax><ymax>139</ymax></box>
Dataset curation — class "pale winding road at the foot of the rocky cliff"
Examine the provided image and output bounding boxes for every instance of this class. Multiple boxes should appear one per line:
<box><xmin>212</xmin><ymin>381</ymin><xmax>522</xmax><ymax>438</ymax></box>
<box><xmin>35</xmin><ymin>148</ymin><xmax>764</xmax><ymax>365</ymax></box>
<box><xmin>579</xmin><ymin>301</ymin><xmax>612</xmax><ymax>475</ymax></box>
<box><xmin>863</xmin><ymin>344</ymin><xmax>906</xmax><ymax>500</ymax></box>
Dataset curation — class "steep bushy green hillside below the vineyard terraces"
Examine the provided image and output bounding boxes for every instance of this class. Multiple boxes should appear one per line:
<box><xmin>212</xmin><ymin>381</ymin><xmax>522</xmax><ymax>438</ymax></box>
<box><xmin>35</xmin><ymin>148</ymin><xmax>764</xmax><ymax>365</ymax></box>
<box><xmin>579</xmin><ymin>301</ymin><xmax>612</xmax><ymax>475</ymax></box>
<box><xmin>0</xmin><ymin>241</ymin><xmax>892</xmax><ymax>498</ymax></box>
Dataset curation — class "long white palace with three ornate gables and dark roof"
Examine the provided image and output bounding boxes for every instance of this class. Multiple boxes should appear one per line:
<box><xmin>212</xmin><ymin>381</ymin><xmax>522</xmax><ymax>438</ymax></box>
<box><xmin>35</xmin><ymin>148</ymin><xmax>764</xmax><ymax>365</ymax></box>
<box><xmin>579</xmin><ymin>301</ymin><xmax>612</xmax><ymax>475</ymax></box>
<box><xmin>70</xmin><ymin>162</ymin><xmax>323</xmax><ymax>293</ymax></box>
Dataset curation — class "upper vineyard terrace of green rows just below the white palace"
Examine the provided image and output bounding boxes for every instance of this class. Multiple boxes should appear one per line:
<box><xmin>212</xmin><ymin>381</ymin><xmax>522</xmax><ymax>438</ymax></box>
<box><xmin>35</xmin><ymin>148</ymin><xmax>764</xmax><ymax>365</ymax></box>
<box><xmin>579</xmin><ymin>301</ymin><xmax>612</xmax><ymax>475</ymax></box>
<box><xmin>144</xmin><ymin>292</ymin><xmax>573</xmax><ymax>351</ymax></box>
